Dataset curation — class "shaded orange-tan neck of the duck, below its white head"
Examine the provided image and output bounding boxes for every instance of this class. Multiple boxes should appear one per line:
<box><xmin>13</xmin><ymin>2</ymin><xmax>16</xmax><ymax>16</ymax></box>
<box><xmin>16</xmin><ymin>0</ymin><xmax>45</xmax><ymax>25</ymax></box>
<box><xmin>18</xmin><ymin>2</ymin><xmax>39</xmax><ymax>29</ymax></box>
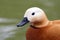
<box><xmin>31</xmin><ymin>19</ymin><xmax>49</xmax><ymax>28</ymax></box>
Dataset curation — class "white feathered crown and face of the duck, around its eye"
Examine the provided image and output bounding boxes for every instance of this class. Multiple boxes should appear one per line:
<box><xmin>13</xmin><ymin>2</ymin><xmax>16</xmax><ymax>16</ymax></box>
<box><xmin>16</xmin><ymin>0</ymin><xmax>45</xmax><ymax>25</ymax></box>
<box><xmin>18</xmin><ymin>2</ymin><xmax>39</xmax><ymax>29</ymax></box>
<box><xmin>24</xmin><ymin>7</ymin><xmax>44</xmax><ymax>22</ymax></box>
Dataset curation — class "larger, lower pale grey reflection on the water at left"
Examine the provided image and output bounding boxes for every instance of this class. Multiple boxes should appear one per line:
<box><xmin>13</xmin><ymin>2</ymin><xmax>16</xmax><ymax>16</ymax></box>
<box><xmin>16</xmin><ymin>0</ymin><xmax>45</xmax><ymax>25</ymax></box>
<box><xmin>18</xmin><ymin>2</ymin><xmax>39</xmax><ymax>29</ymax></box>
<box><xmin>0</xmin><ymin>25</ymin><xmax>16</xmax><ymax>40</ymax></box>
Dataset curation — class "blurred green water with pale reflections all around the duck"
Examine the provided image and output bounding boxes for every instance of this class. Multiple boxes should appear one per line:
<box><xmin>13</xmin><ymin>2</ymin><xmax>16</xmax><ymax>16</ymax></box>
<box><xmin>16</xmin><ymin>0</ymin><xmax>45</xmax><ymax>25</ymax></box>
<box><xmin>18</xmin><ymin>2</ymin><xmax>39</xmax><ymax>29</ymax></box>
<box><xmin>0</xmin><ymin>0</ymin><xmax>60</xmax><ymax>40</ymax></box>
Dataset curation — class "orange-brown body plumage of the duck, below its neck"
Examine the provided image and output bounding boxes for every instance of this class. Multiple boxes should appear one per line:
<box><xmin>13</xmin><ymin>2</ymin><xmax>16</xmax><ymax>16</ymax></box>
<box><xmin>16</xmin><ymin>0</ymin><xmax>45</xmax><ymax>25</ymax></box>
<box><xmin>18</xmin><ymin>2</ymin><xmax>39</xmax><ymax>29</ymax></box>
<box><xmin>26</xmin><ymin>20</ymin><xmax>60</xmax><ymax>40</ymax></box>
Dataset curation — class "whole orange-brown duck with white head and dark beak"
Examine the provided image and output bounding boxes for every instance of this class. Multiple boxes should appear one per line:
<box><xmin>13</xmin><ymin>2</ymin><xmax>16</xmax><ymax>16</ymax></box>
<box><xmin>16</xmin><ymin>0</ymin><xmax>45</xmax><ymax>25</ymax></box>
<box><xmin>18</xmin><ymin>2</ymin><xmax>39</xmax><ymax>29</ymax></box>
<box><xmin>17</xmin><ymin>7</ymin><xmax>60</xmax><ymax>40</ymax></box>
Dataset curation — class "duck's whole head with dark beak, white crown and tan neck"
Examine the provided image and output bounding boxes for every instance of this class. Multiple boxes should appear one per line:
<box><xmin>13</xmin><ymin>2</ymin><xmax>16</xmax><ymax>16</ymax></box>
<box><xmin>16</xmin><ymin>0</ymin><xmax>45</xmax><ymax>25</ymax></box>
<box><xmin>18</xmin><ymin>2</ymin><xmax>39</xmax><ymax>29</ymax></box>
<box><xmin>17</xmin><ymin>7</ymin><xmax>48</xmax><ymax>27</ymax></box>
